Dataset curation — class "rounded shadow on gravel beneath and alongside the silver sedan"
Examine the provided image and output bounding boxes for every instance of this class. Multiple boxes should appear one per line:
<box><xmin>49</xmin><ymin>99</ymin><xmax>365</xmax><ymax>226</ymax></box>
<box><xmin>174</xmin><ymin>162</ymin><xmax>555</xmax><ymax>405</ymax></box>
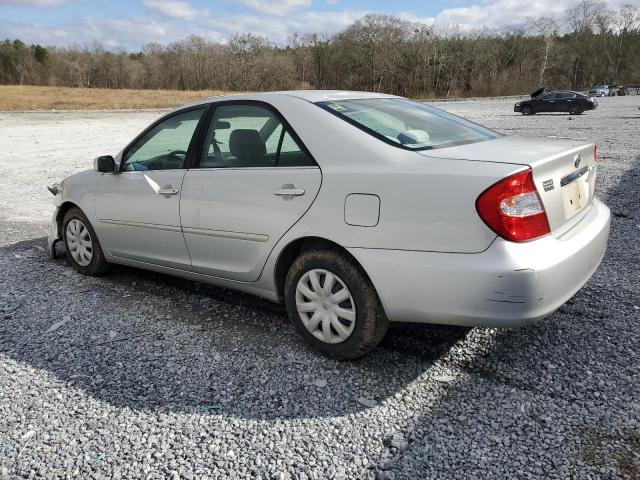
<box><xmin>0</xmin><ymin>238</ymin><xmax>469</xmax><ymax>419</ymax></box>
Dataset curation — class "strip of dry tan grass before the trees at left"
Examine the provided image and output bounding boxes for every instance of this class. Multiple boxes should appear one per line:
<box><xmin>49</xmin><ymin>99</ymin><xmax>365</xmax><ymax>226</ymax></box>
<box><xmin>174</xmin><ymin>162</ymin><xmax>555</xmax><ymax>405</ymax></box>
<box><xmin>0</xmin><ymin>85</ymin><xmax>235</xmax><ymax>111</ymax></box>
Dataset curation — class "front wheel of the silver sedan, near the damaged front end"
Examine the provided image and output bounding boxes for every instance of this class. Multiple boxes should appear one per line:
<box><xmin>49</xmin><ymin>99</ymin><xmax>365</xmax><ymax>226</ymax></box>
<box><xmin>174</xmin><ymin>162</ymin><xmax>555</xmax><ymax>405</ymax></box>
<box><xmin>62</xmin><ymin>207</ymin><xmax>111</xmax><ymax>276</ymax></box>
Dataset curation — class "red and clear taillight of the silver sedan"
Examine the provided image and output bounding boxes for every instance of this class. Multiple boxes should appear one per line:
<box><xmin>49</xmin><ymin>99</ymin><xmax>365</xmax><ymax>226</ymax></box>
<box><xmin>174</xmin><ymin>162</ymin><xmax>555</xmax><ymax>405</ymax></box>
<box><xmin>476</xmin><ymin>168</ymin><xmax>551</xmax><ymax>242</ymax></box>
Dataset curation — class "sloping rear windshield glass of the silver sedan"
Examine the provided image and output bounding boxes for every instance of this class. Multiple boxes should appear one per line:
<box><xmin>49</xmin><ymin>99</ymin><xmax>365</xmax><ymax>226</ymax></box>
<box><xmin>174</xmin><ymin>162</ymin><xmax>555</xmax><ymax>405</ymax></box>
<box><xmin>316</xmin><ymin>98</ymin><xmax>500</xmax><ymax>150</ymax></box>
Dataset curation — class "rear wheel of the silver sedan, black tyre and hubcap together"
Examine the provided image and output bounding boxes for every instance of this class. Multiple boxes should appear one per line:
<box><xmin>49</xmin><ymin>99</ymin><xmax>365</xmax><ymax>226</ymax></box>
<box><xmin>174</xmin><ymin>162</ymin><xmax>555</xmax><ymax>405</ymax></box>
<box><xmin>285</xmin><ymin>250</ymin><xmax>389</xmax><ymax>360</ymax></box>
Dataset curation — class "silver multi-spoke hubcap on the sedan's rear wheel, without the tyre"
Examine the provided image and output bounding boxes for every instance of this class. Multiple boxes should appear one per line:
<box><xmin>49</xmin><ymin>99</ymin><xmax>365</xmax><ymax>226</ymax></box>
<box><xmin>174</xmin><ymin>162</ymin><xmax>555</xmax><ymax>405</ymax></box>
<box><xmin>296</xmin><ymin>268</ymin><xmax>356</xmax><ymax>343</ymax></box>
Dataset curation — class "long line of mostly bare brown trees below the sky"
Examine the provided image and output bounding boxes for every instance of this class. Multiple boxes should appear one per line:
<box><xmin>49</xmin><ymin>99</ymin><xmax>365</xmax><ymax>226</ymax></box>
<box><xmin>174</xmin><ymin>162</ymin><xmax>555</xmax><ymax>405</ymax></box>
<box><xmin>0</xmin><ymin>0</ymin><xmax>640</xmax><ymax>98</ymax></box>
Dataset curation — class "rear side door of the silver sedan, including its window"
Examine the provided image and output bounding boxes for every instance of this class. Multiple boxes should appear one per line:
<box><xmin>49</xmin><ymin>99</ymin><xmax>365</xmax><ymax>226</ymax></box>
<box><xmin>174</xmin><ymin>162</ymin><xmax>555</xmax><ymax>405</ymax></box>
<box><xmin>180</xmin><ymin>102</ymin><xmax>322</xmax><ymax>282</ymax></box>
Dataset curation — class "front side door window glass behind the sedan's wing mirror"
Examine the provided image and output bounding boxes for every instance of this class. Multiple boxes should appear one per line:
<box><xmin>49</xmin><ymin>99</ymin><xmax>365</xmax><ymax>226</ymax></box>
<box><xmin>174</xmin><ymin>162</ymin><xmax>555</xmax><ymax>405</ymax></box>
<box><xmin>121</xmin><ymin>108</ymin><xmax>205</xmax><ymax>172</ymax></box>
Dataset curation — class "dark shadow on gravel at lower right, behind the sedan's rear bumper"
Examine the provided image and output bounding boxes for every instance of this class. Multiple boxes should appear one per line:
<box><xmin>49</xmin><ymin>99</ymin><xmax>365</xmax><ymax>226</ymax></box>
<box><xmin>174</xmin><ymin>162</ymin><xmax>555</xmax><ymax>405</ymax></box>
<box><xmin>370</xmin><ymin>156</ymin><xmax>640</xmax><ymax>478</ymax></box>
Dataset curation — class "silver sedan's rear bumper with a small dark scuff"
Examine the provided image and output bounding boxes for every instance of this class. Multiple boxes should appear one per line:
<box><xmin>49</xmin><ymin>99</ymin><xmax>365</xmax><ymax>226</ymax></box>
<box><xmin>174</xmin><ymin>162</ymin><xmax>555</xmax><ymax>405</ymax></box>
<box><xmin>349</xmin><ymin>199</ymin><xmax>610</xmax><ymax>327</ymax></box>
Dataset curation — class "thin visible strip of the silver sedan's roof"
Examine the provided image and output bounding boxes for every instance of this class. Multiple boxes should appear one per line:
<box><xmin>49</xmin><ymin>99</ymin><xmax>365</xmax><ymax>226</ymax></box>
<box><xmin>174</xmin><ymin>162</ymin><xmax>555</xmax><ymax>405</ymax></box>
<box><xmin>179</xmin><ymin>90</ymin><xmax>401</xmax><ymax>108</ymax></box>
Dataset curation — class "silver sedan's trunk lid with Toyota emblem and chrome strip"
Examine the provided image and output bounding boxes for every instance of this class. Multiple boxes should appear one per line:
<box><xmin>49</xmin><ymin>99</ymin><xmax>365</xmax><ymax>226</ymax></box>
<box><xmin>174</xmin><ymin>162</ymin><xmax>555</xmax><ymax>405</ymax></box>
<box><xmin>419</xmin><ymin>137</ymin><xmax>596</xmax><ymax>237</ymax></box>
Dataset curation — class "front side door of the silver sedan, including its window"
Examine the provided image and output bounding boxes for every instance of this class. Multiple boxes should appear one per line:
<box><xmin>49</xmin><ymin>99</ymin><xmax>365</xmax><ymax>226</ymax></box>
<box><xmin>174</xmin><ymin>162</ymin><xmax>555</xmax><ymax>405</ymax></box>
<box><xmin>95</xmin><ymin>107</ymin><xmax>206</xmax><ymax>270</ymax></box>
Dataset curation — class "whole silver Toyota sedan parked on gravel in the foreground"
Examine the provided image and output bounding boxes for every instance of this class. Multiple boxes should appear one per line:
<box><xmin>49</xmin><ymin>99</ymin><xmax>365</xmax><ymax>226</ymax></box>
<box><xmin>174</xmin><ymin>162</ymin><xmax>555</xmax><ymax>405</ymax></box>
<box><xmin>48</xmin><ymin>90</ymin><xmax>610</xmax><ymax>359</ymax></box>
